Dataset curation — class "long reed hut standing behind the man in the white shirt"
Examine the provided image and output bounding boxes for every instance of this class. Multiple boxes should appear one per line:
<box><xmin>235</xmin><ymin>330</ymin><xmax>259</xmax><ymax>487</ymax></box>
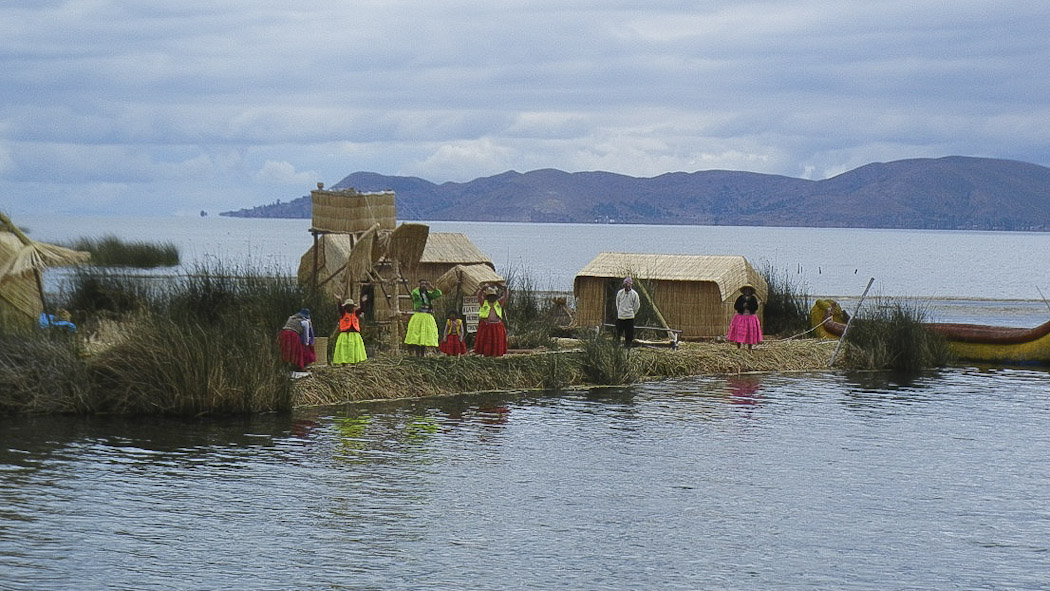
<box><xmin>573</xmin><ymin>252</ymin><xmax>769</xmax><ymax>339</ymax></box>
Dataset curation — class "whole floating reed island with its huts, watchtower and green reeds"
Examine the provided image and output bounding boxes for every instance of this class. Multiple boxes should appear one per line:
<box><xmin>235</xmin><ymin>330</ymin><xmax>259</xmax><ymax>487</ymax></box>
<box><xmin>0</xmin><ymin>198</ymin><xmax>953</xmax><ymax>417</ymax></box>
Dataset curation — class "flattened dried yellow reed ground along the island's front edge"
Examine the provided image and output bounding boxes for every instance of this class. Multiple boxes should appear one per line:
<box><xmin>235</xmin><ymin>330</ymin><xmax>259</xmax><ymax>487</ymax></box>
<box><xmin>292</xmin><ymin>339</ymin><xmax>837</xmax><ymax>406</ymax></box>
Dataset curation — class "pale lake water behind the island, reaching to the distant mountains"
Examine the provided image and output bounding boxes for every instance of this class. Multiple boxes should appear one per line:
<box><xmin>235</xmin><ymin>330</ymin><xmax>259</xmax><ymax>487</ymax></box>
<box><xmin>17</xmin><ymin>216</ymin><xmax>1050</xmax><ymax>326</ymax></box>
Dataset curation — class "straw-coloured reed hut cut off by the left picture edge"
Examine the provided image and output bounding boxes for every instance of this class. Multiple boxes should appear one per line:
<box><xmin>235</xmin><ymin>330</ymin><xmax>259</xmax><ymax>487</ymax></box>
<box><xmin>0</xmin><ymin>213</ymin><xmax>90</xmax><ymax>326</ymax></box>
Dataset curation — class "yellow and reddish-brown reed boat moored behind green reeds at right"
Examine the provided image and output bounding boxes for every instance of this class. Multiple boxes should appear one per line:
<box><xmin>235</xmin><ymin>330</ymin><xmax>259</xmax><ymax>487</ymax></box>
<box><xmin>810</xmin><ymin>299</ymin><xmax>1050</xmax><ymax>365</ymax></box>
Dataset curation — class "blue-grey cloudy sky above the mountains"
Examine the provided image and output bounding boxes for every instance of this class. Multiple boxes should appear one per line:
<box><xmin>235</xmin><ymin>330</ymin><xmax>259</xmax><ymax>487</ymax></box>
<box><xmin>0</xmin><ymin>0</ymin><xmax>1050</xmax><ymax>215</ymax></box>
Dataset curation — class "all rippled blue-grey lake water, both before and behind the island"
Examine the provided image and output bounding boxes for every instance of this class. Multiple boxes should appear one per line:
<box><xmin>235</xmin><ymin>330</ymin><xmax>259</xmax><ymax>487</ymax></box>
<box><xmin>6</xmin><ymin>218</ymin><xmax>1050</xmax><ymax>591</ymax></box>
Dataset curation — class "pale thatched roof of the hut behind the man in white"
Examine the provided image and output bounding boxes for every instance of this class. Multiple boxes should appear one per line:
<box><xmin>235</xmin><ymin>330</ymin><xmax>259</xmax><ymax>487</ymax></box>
<box><xmin>576</xmin><ymin>252</ymin><xmax>769</xmax><ymax>301</ymax></box>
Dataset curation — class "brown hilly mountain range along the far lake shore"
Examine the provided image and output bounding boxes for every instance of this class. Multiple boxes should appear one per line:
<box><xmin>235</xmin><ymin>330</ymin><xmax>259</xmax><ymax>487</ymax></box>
<box><xmin>221</xmin><ymin>156</ymin><xmax>1050</xmax><ymax>231</ymax></box>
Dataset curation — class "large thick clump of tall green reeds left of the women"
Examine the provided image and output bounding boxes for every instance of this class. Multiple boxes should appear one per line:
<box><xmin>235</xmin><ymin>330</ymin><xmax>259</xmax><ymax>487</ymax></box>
<box><xmin>0</xmin><ymin>261</ymin><xmax>319</xmax><ymax>416</ymax></box>
